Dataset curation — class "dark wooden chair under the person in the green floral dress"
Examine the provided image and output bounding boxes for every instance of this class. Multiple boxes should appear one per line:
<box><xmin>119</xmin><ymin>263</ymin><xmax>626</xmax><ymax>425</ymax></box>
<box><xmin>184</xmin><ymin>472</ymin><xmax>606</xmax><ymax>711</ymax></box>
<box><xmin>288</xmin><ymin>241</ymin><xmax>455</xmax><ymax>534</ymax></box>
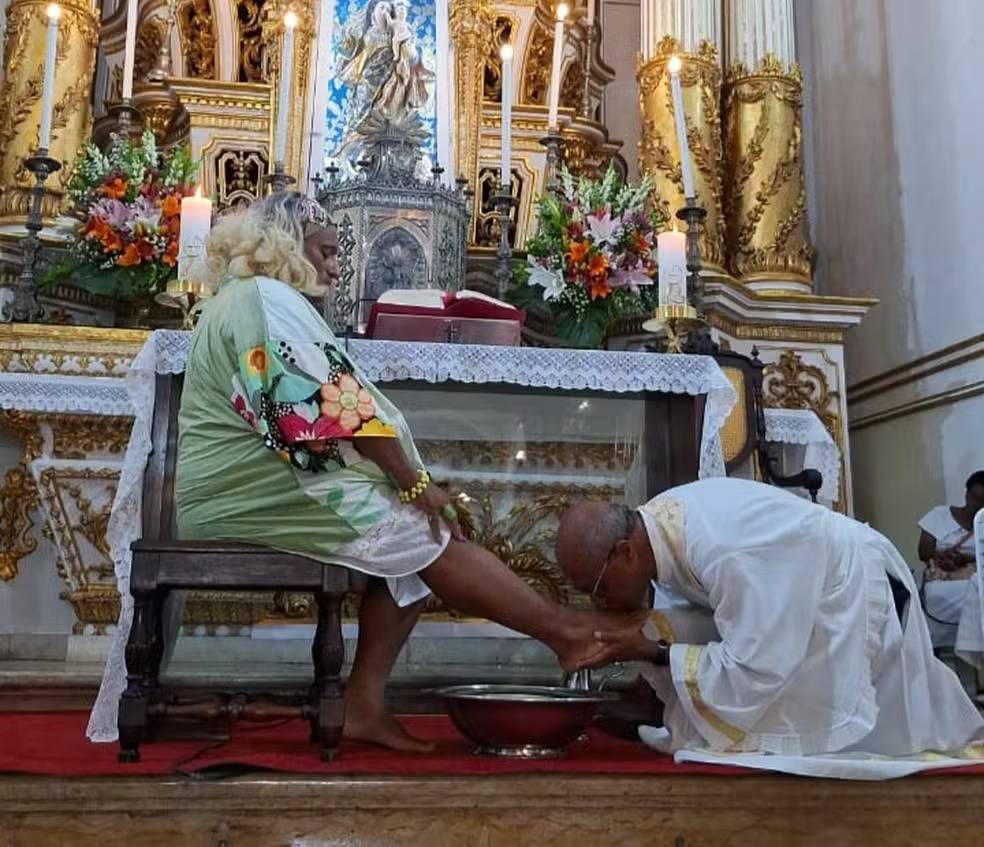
<box><xmin>118</xmin><ymin>375</ymin><xmax>367</xmax><ymax>762</ymax></box>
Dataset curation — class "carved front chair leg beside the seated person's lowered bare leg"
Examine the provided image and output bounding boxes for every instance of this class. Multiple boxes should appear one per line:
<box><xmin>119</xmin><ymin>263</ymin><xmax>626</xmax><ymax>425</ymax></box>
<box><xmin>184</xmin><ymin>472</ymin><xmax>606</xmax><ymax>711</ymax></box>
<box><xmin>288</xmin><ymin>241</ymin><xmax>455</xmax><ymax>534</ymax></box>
<box><xmin>311</xmin><ymin>591</ymin><xmax>345</xmax><ymax>762</ymax></box>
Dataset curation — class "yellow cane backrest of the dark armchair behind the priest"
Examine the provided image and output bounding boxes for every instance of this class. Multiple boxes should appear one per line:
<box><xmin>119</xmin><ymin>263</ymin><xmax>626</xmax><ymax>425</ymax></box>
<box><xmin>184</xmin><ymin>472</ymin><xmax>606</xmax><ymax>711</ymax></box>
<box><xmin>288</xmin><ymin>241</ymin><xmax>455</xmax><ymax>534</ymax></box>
<box><xmin>714</xmin><ymin>350</ymin><xmax>765</xmax><ymax>475</ymax></box>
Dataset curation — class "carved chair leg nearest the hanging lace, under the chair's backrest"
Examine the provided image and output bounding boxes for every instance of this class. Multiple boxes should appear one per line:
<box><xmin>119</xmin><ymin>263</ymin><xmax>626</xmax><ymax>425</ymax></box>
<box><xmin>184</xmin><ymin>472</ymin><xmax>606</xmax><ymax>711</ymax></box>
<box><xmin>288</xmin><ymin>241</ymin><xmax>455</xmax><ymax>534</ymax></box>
<box><xmin>117</xmin><ymin>590</ymin><xmax>158</xmax><ymax>762</ymax></box>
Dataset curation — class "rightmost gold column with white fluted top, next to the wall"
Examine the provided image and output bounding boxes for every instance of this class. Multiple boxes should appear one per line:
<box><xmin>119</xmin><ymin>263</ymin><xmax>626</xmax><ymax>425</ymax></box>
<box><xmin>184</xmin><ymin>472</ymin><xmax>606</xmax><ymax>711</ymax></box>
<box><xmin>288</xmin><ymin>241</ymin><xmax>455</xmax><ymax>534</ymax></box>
<box><xmin>724</xmin><ymin>0</ymin><xmax>813</xmax><ymax>291</ymax></box>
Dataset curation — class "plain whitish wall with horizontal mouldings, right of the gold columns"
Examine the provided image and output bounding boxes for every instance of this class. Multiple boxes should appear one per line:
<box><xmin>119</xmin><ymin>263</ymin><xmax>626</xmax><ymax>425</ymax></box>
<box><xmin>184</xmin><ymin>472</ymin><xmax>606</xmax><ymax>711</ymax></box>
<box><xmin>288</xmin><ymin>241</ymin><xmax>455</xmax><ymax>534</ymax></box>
<box><xmin>796</xmin><ymin>0</ymin><xmax>984</xmax><ymax>561</ymax></box>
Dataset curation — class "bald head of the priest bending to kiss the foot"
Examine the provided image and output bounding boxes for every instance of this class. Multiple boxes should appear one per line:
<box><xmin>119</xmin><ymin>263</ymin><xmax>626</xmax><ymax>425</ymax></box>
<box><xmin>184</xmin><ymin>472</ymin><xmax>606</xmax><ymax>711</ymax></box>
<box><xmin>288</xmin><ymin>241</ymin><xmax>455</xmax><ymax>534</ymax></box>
<box><xmin>557</xmin><ymin>502</ymin><xmax>656</xmax><ymax>611</ymax></box>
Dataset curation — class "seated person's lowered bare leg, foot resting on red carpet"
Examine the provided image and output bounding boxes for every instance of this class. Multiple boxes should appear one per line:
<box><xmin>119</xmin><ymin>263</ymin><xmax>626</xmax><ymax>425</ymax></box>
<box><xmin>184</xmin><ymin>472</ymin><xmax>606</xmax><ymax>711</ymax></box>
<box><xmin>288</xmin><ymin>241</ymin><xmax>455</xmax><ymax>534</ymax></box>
<box><xmin>343</xmin><ymin>579</ymin><xmax>434</xmax><ymax>753</ymax></box>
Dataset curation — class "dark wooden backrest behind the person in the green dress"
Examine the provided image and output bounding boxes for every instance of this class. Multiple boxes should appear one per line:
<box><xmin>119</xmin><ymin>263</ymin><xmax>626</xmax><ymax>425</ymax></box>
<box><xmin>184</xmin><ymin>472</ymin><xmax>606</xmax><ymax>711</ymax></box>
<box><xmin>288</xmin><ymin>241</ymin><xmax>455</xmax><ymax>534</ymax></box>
<box><xmin>142</xmin><ymin>374</ymin><xmax>184</xmax><ymax>540</ymax></box>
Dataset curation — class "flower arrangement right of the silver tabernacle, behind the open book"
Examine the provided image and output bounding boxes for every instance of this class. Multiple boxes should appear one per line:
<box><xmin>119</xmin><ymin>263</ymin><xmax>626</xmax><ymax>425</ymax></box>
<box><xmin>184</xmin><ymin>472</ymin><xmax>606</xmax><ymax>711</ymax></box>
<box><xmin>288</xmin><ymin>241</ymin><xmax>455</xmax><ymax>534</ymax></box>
<box><xmin>511</xmin><ymin>165</ymin><xmax>660</xmax><ymax>347</ymax></box>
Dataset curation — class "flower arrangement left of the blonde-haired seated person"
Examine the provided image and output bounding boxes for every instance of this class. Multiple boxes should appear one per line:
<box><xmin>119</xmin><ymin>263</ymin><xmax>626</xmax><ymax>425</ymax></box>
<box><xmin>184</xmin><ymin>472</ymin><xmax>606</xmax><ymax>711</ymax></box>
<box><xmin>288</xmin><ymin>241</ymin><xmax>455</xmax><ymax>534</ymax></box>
<box><xmin>45</xmin><ymin>131</ymin><xmax>197</xmax><ymax>299</ymax></box>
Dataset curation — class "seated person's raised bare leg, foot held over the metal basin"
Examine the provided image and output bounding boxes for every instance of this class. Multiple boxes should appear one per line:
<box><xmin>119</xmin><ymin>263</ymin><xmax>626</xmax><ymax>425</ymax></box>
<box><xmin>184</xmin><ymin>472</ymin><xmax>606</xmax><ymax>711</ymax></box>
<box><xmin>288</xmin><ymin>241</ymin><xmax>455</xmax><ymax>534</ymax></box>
<box><xmin>420</xmin><ymin>541</ymin><xmax>643</xmax><ymax>670</ymax></box>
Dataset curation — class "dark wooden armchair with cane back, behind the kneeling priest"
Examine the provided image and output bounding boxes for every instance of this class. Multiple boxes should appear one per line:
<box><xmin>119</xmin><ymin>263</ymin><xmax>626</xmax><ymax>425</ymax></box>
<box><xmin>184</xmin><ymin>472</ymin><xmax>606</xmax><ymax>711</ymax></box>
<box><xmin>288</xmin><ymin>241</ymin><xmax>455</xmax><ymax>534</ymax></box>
<box><xmin>714</xmin><ymin>349</ymin><xmax>823</xmax><ymax>503</ymax></box>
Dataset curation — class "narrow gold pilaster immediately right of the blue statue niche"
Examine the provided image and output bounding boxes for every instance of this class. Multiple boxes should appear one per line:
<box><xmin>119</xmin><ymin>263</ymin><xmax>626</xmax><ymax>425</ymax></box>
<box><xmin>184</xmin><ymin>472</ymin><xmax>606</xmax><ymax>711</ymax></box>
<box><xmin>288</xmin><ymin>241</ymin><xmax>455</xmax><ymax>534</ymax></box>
<box><xmin>450</xmin><ymin>0</ymin><xmax>495</xmax><ymax>199</ymax></box>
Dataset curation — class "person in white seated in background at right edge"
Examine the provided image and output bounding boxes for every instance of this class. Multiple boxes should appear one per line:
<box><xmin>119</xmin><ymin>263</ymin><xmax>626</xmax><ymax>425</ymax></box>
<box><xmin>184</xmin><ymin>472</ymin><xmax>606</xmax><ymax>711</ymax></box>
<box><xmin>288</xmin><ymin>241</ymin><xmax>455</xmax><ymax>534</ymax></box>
<box><xmin>919</xmin><ymin>471</ymin><xmax>984</xmax><ymax>649</ymax></box>
